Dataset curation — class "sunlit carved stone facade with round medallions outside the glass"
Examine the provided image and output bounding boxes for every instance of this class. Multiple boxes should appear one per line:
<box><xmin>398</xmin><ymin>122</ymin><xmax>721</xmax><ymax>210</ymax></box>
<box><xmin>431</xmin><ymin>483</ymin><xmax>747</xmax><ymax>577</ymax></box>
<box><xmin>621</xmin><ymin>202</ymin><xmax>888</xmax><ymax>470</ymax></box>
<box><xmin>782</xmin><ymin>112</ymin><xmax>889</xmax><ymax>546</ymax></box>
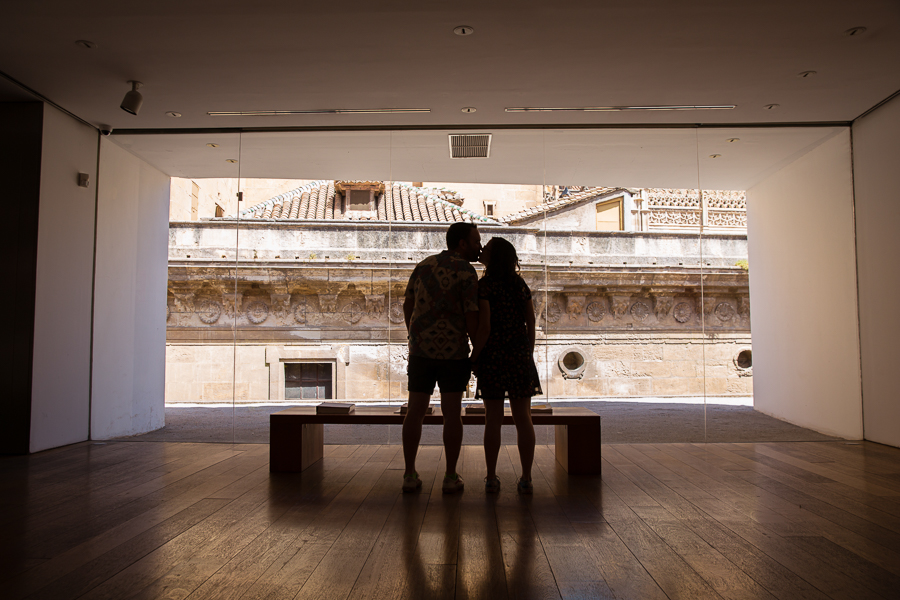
<box><xmin>166</xmin><ymin>186</ymin><xmax>752</xmax><ymax>403</ymax></box>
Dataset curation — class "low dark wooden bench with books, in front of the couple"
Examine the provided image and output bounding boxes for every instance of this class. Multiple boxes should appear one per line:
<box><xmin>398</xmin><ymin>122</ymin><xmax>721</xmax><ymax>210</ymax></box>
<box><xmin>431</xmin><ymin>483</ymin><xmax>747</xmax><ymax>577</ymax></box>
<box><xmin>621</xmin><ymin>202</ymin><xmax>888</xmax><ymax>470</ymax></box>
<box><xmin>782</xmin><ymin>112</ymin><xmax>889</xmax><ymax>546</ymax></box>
<box><xmin>269</xmin><ymin>406</ymin><xmax>600</xmax><ymax>475</ymax></box>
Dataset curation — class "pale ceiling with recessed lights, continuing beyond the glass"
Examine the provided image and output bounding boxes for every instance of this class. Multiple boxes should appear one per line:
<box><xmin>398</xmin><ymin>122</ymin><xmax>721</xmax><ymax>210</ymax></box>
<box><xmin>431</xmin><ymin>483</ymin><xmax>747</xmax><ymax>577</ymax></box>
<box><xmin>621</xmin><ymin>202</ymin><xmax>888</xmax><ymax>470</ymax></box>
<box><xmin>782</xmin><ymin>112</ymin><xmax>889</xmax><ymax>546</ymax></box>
<box><xmin>0</xmin><ymin>0</ymin><xmax>900</xmax><ymax>188</ymax></box>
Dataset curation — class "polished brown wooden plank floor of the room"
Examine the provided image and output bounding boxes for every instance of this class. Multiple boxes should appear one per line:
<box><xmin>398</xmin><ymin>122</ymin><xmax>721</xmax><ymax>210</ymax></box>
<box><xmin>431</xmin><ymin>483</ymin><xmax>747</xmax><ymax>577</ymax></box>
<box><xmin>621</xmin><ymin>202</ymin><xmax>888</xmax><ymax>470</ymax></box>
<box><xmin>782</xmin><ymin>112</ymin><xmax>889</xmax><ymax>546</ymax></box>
<box><xmin>0</xmin><ymin>442</ymin><xmax>900</xmax><ymax>600</ymax></box>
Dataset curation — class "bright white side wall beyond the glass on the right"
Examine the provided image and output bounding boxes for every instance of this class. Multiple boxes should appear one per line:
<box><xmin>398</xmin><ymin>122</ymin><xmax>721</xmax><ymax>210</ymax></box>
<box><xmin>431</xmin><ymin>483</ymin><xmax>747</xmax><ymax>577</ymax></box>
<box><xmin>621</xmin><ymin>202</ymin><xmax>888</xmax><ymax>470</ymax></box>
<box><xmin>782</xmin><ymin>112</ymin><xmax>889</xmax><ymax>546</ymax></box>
<box><xmin>747</xmin><ymin>130</ymin><xmax>863</xmax><ymax>439</ymax></box>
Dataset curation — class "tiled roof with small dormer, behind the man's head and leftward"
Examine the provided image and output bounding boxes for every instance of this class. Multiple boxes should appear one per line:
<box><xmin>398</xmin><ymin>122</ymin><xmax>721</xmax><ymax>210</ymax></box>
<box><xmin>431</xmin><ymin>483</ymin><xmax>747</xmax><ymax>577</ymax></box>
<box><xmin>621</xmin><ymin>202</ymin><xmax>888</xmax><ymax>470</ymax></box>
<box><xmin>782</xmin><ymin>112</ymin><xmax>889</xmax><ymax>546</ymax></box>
<box><xmin>234</xmin><ymin>180</ymin><xmax>500</xmax><ymax>225</ymax></box>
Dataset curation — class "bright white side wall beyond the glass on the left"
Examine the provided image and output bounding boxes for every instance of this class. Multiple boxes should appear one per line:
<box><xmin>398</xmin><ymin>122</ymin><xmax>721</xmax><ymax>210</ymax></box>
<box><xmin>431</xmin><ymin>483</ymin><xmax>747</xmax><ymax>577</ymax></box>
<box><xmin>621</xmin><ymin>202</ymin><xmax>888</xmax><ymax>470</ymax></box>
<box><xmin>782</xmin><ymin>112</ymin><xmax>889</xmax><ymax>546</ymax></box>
<box><xmin>91</xmin><ymin>139</ymin><xmax>169</xmax><ymax>439</ymax></box>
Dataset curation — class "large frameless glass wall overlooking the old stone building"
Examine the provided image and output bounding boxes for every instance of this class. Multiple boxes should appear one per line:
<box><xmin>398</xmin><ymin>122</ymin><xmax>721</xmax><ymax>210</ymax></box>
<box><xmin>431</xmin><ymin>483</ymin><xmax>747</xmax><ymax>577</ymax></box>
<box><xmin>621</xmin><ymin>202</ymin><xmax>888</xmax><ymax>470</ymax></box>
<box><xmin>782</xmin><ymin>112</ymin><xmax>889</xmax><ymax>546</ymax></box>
<box><xmin>132</xmin><ymin>128</ymin><xmax>844</xmax><ymax>443</ymax></box>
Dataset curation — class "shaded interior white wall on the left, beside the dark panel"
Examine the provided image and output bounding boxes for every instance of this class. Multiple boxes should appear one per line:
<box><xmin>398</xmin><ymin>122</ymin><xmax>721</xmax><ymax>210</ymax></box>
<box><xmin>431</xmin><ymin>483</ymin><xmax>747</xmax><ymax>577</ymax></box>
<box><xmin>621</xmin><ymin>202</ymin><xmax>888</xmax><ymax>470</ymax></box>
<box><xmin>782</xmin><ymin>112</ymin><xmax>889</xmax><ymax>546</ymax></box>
<box><xmin>29</xmin><ymin>105</ymin><xmax>98</xmax><ymax>452</ymax></box>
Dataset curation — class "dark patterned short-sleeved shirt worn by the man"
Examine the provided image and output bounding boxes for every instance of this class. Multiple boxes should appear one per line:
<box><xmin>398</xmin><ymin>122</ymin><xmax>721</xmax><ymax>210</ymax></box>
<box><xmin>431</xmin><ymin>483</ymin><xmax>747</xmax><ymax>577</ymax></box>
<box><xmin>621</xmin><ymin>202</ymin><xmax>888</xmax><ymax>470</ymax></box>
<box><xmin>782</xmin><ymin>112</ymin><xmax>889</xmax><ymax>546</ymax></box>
<box><xmin>406</xmin><ymin>250</ymin><xmax>478</xmax><ymax>360</ymax></box>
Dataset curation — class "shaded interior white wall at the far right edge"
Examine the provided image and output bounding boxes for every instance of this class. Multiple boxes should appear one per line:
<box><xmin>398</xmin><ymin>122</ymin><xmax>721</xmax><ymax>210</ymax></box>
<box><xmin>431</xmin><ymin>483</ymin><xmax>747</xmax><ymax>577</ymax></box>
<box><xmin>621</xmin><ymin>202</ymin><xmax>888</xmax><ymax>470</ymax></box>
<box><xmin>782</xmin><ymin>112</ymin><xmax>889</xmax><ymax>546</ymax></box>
<box><xmin>853</xmin><ymin>98</ymin><xmax>900</xmax><ymax>446</ymax></box>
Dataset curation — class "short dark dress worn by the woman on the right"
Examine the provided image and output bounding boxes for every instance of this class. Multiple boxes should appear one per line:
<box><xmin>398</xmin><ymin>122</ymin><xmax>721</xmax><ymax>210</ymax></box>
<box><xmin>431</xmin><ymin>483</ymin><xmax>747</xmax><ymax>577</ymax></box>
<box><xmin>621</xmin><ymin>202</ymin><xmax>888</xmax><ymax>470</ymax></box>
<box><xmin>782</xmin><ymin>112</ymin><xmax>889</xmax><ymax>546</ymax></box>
<box><xmin>475</xmin><ymin>275</ymin><xmax>543</xmax><ymax>400</ymax></box>
